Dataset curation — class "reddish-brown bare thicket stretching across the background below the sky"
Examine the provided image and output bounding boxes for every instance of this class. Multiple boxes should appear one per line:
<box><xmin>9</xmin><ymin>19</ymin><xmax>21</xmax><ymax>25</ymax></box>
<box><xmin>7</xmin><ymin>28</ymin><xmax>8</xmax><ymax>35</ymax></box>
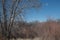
<box><xmin>0</xmin><ymin>20</ymin><xmax>60</xmax><ymax>40</ymax></box>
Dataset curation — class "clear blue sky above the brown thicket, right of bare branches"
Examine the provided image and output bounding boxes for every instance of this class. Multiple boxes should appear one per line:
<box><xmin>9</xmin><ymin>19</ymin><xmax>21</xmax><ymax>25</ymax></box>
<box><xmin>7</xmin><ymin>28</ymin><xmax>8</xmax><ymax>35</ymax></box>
<box><xmin>25</xmin><ymin>0</ymin><xmax>60</xmax><ymax>21</ymax></box>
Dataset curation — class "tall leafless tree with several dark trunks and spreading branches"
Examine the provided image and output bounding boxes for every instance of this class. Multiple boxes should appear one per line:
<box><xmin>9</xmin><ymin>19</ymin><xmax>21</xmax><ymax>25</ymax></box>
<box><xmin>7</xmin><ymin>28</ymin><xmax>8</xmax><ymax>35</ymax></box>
<box><xmin>0</xmin><ymin>0</ymin><xmax>41</xmax><ymax>40</ymax></box>
